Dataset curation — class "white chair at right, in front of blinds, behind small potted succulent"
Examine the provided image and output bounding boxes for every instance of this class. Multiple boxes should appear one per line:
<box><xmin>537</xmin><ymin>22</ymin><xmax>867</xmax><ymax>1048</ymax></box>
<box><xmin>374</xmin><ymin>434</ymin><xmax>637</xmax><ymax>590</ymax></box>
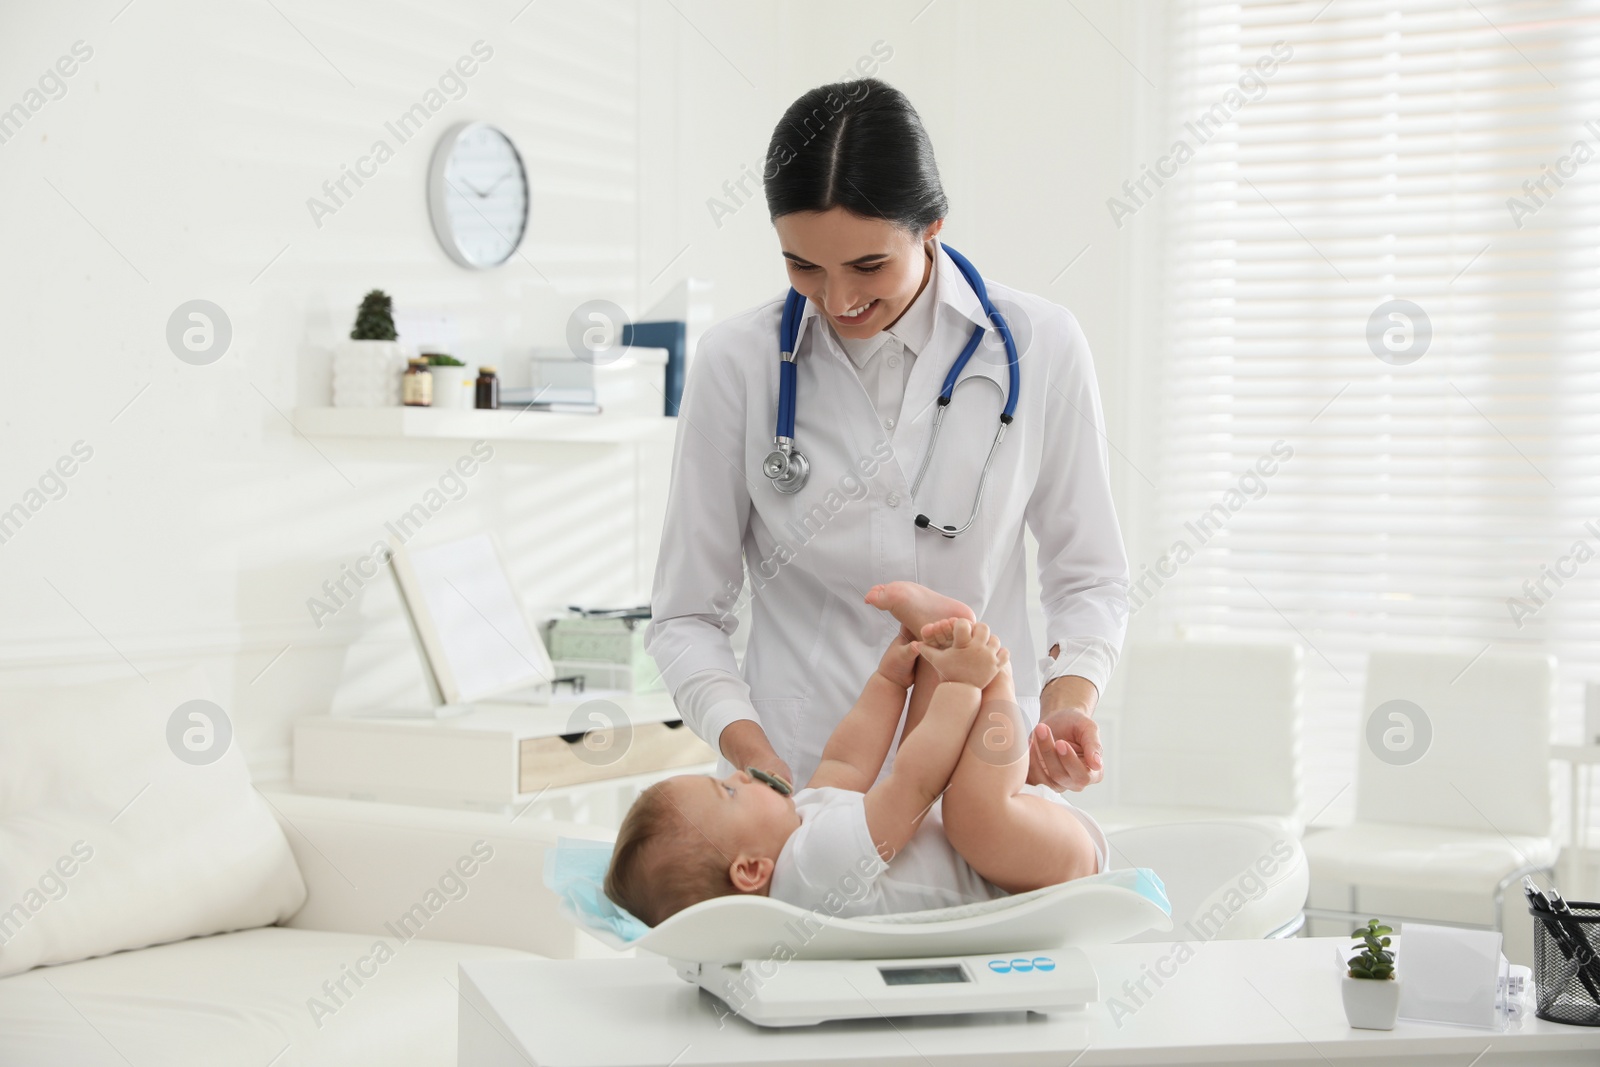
<box><xmin>1304</xmin><ymin>653</ymin><xmax>1558</xmax><ymax>933</ymax></box>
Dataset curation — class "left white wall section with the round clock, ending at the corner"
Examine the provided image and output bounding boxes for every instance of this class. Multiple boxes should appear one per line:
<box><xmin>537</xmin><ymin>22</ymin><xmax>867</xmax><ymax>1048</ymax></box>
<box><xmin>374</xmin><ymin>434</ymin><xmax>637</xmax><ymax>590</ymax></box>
<box><xmin>0</xmin><ymin>2</ymin><xmax>653</xmax><ymax>776</ymax></box>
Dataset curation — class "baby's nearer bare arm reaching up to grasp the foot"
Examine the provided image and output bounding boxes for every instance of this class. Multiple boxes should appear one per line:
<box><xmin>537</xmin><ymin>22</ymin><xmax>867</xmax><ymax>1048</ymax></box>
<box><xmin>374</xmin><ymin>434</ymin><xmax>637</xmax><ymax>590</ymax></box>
<box><xmin>866</xmin><ymin>619</ymin><xmax>1005</xmax><ymax>861</ymax></box>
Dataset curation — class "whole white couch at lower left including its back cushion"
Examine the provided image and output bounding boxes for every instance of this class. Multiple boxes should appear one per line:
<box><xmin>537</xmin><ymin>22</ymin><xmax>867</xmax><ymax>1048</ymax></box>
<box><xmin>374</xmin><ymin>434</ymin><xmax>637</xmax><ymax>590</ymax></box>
<box><xmin>0</xmin><ymin>672</ymin><xmax>608</xmax><ymax>1067</ymax></box>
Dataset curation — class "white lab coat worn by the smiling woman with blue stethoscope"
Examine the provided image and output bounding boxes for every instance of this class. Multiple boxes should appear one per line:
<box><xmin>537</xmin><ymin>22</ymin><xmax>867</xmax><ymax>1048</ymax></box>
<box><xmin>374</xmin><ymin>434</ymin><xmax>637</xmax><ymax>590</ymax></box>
<box><xmin>645</xmin><ymin>244</ymin><xmax>1128</xmax><ymax>784</ymax></box>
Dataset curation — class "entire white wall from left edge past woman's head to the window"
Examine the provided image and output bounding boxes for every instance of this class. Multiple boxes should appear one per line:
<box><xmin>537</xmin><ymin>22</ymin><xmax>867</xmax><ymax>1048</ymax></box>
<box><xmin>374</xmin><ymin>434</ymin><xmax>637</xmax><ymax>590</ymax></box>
<box><xmin>0</xmin><ymin>0</ymin><xmax>1155</xmax><ymax>777</ymax></box>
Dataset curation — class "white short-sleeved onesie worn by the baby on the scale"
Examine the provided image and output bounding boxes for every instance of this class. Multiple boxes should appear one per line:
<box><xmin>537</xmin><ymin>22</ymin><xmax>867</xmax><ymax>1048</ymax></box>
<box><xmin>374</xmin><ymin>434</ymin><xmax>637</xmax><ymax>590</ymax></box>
<box><xmin>768</xmin><ymin>785</ymin><xmax>1106</xmax><ymax>917</ymax></box>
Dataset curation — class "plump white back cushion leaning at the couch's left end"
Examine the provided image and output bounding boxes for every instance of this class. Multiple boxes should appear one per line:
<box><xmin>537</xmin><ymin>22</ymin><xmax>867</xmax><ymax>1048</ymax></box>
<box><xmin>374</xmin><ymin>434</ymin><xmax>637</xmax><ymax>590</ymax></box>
<box><xmin>0</xmin><ymin>667</ymin><xmax>306</xmax><ymax>976</ymax></box>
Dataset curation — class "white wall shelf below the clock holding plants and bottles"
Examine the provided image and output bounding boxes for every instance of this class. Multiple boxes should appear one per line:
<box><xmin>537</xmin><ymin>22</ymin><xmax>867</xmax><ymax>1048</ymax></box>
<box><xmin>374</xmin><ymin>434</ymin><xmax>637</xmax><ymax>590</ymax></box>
<box><xmin>294</xmin><ymin>408</ymin><xmax>678</xmax><ymax>445</ymax></box>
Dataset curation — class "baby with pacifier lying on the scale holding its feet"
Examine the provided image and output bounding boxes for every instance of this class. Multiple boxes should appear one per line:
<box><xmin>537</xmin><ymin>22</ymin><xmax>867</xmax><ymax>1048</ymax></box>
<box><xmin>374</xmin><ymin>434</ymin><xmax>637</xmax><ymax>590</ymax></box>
<box><xmin>605</xmin><ymin>582</ymin><xmax>1106</xmax><ymax>926</ymax></box>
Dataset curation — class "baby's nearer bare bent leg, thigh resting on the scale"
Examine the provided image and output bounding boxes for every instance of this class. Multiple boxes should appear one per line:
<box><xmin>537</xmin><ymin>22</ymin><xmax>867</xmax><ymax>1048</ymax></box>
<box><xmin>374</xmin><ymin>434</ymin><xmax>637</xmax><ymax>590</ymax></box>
<box><xmin>944</xmin><ymin>664</ymin><xmax>1098</xmax><ymax>893</ymax></box>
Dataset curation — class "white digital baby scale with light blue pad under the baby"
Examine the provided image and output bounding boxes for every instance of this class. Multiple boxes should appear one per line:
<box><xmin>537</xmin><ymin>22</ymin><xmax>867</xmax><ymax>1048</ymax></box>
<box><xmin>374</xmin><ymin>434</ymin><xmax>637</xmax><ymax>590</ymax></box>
<box><xmin>544</xmin><ymin>837</ymin><xmax>1173</xmax><ymax>1027</ymax></box>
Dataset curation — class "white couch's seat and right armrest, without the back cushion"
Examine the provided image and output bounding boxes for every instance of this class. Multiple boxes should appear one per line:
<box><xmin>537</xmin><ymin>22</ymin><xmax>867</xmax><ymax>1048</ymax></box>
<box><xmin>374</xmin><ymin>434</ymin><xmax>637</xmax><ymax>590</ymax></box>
<box><xmin>0</xmin><ymin>790</ymin><xmax>606</xmax><ymax>1067</ymax></box>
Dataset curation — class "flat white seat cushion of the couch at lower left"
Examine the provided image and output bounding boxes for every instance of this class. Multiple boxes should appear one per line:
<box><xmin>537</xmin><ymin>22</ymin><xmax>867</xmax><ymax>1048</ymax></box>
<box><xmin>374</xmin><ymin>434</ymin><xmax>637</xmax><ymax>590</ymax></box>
<box><xmin>0</xmin><ymin>926</ymin><xmax>541</xmax><ymax>1067</ymax></box>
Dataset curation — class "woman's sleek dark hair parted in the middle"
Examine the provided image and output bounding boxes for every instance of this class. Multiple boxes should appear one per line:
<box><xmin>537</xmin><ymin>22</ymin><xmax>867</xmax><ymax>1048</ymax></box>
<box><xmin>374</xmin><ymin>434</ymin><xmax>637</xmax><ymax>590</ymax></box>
<box><xmin>762</xmin><ymin>78</ymin><xmax>950</xmax><ymax>237</ymax></box>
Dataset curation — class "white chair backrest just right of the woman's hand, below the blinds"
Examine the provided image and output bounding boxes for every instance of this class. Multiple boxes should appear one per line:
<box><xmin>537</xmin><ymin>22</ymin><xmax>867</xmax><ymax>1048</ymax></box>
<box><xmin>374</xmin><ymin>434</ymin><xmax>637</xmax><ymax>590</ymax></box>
<box><xmin>1072</xmin><ymin>640</ymin><xmax>1304</xmax><ymax>838</ymax></box>
